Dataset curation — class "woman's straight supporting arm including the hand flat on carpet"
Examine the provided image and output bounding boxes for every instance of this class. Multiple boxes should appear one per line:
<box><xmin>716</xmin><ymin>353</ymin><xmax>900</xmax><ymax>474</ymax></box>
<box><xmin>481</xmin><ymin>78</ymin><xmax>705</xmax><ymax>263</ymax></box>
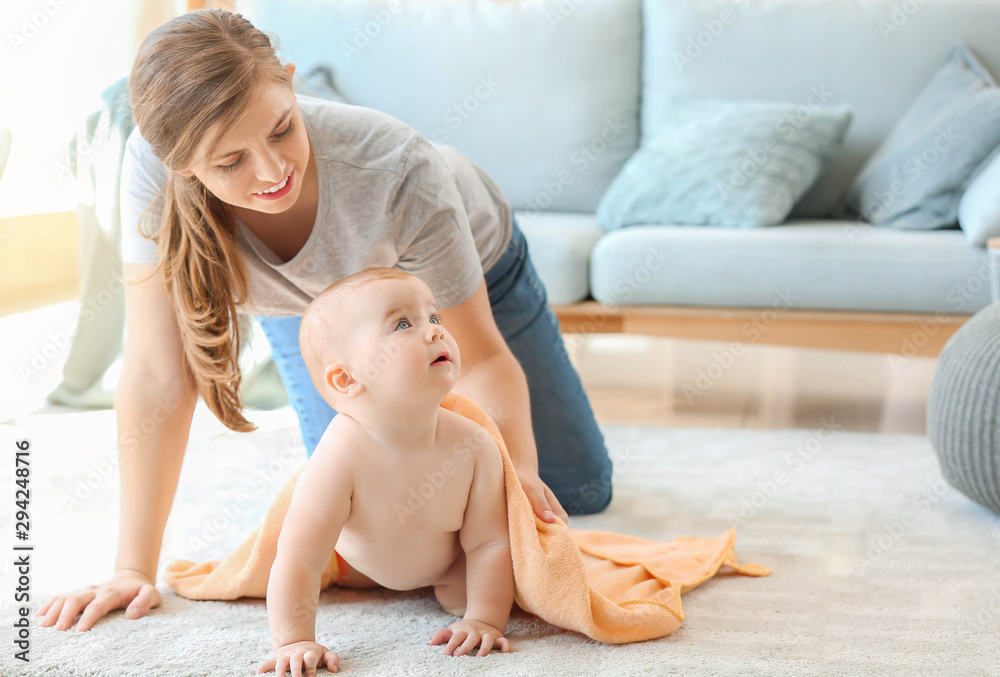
<box><xmin>46</xmin><ymin>263</ymin><xmax>198</xmax><ymax>632</ymax></box>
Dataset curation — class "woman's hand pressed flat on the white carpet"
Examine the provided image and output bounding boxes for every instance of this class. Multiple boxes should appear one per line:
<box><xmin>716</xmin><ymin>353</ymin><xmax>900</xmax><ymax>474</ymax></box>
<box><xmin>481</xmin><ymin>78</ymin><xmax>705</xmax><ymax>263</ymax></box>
<box><xmin>35</xmin><ymin>569</ymin><xmax>160</xmax><ymax>632</ymax></box>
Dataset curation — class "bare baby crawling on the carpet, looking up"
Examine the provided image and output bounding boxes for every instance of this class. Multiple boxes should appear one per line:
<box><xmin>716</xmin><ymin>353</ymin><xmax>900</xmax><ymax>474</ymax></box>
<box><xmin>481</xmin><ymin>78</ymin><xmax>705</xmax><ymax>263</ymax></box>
<box><xmin>257</xmin><ymin>268</ymin><xmax>514</xmax><ymax>676</ymax></box>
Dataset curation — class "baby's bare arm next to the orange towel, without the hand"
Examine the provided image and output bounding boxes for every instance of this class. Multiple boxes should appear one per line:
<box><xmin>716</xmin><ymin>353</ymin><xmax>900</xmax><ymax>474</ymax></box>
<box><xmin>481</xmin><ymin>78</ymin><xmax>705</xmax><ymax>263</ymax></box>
<box><xmin>459</xmin><ymin>430</ymin><xmax>514</xmax><ymax>631</ymax></box>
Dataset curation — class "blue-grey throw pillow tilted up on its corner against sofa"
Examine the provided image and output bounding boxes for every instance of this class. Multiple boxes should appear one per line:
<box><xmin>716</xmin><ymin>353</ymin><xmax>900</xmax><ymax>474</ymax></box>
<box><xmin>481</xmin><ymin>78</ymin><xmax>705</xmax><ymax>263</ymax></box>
<box><xmin>846</xmin><ymin>45</ymin><xmax>1000</xmax><ymax>230</ymax></box>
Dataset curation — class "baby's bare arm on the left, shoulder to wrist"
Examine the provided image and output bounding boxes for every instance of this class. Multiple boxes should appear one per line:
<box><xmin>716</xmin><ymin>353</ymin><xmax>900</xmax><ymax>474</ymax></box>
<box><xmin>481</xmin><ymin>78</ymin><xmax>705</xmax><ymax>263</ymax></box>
<box><xmin>267</xmin><ymin>424</ymin><xmax>353</xmax><ymax>670</ymax></box>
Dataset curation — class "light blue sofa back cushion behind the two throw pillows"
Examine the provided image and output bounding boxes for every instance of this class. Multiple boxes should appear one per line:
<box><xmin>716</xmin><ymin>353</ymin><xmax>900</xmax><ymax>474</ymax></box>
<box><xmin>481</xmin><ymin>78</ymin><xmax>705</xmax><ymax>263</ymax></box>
<box><xmin>641</xmin><ymin>0</ymin><xmax>1000</xmax><ymax>217</ymax></box>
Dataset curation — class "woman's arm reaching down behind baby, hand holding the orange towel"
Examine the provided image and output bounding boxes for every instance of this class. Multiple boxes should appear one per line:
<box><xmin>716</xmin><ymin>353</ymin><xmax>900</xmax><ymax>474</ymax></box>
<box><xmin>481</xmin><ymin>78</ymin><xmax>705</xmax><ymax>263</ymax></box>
<box><xmin>438</xmin><ymin>278</ymin><xmax>569</xmax><ymax>522</ymax></box>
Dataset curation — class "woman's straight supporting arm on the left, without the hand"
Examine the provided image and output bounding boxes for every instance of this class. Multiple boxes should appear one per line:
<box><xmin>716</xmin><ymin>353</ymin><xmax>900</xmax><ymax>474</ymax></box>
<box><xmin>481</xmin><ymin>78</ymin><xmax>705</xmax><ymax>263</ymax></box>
<box><xmin>115</xmin><ymin>263</ymin><xmax>198</xmax><ymax>583</ymax></box>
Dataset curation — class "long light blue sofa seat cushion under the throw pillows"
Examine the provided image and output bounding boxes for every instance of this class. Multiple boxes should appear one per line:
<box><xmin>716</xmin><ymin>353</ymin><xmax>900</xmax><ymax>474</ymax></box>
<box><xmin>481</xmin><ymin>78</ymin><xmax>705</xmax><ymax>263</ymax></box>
<box><xmin>590</xmin><ymin>219</ymin><xmax>990</xmax><ymax>314</ymax></box>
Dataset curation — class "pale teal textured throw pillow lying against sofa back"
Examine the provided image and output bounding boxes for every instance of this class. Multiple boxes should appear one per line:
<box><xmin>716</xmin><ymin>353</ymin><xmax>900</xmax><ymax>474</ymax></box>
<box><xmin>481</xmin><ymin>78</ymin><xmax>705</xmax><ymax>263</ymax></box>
<box><xmin>597</xmin><ymin>99</ymin><xmax>851</xmax><ymax>230</ymax></box>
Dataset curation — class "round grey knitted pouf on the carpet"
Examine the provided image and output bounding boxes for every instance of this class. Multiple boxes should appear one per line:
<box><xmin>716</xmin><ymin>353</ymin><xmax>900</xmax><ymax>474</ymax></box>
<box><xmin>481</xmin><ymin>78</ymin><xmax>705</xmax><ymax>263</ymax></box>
<box><xmin>927</xmin><ymin>303</ymin><xmax>1000</xmax><ymax>514</ymax></box>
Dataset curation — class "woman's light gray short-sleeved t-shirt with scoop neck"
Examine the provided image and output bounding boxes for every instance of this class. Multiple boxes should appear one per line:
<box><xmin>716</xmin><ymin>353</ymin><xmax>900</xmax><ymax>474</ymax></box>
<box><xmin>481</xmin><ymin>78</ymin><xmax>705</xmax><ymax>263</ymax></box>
<box><xmin>121</xmin><ymin>94</ymin><xmax>512</xmax><ymax>316</ymax></box>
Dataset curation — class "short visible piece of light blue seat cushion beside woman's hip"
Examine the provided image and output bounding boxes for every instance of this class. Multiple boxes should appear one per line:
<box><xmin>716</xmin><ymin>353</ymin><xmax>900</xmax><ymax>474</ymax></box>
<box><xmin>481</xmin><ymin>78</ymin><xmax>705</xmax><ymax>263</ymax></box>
<box><xmin>514</xmin><ymin>210</ymin><xmax>604</xmax><ymax>304</ymax></box>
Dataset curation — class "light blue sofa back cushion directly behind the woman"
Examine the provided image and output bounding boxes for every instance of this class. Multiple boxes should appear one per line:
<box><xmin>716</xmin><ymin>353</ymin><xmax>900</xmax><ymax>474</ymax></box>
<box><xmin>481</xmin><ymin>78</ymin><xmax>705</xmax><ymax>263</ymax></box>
<box><xmin>237</xmin><ymin>0</ymin><xmax>641</xmax><ymax>212</ymax></box>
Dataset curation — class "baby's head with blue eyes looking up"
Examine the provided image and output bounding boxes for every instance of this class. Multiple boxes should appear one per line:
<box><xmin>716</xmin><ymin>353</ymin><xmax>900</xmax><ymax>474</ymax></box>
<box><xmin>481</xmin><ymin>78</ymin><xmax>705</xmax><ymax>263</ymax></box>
<box><xmin>299</xmin><ymin>268</ymin><xmax>461</xmax><ymax>411</ymax></box>
